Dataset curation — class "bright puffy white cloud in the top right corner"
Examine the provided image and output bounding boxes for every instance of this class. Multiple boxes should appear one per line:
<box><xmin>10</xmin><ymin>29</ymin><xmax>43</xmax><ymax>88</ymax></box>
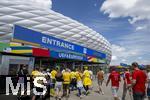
<box><xmin>100</xmin><ymin>0</ymin><xmax>150</xmax><ymax>30</ymax></box>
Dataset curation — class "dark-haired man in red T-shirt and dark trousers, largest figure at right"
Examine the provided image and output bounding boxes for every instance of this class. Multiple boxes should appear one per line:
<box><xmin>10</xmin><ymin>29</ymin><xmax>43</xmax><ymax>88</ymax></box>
<box><xmin>132</xmin><ymin>62</ymin><xmax>147</xmax><ymax>100</ymax></box>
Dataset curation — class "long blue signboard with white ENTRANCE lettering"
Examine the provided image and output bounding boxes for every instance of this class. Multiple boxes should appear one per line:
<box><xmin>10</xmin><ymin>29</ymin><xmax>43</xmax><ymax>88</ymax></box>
<box><xmin>13</xmin><ymin>25</ymin><xmax>106</xmax><ymax>59</ymax></box>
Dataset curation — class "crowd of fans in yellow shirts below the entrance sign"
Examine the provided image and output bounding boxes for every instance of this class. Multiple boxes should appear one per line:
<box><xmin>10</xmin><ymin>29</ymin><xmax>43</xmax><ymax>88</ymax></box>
<box><xmin>28</xmin><ymin>66</ymin><xmax>93</xmax><ymax>100</ymax></box>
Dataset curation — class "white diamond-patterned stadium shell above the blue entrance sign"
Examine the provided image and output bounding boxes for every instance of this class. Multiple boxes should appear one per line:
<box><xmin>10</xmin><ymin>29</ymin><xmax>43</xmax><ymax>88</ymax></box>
<box><xmin>0</xmin><ymin>0</ymin><xmax>111</xmax><ymax>59</ymax></box>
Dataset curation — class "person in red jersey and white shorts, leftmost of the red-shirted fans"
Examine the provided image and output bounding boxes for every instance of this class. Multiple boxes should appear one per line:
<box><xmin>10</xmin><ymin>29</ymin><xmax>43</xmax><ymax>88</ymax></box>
<box><xmin>106</xmin><ymin>68</ymin><xmax>121</xmax><ymax>100</ymax></box>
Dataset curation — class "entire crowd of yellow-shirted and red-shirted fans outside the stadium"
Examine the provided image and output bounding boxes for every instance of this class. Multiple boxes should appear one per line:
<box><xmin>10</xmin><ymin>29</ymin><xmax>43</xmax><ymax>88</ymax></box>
<box><xmin>18</xmin><ymin>62</ymin><xmax>150</xmax><ymax>100</ymax></box>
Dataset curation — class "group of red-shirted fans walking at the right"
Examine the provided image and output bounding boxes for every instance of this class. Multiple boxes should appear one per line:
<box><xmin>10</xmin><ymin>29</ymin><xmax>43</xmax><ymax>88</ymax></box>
<box><xmin>106</xmin><ymin>62</ymin><xmax>150</xmax><ymax>100</ymax></box>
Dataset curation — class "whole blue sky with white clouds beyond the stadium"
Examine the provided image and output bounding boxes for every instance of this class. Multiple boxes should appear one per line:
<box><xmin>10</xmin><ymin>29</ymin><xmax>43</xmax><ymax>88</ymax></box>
<box><xmin>48</xmin><ymin>0</ymin><xmax>150</xmax><ymax>65</ymax></box>
